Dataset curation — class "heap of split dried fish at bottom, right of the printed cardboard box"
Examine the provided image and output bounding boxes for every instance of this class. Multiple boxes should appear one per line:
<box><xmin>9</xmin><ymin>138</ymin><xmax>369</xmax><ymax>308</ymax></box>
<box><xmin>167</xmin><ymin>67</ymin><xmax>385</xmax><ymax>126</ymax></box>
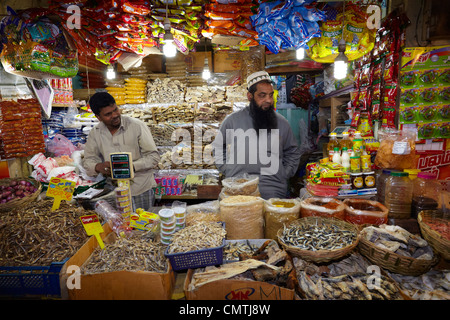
<box><xmin>297</xmin><ymin>271</ymin><xmax>402</xmax><ymax>300</ymax></box>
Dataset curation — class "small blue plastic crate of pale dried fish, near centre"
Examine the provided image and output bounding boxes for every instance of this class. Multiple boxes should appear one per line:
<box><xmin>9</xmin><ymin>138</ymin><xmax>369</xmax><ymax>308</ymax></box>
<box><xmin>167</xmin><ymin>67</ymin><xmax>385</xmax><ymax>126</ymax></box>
<box><xmin>164</xmin><ymin>223</ymin><xmax>225</xmax><ymax>271</ymax></box>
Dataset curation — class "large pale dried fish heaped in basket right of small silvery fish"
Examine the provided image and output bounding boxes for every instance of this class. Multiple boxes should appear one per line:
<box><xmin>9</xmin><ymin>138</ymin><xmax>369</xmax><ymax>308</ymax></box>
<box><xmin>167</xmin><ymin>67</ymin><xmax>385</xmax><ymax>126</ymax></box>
<box><xmin>361</xmin><ymin>224</ymin><xmax>433</xmax><ymax>260</ymax></box>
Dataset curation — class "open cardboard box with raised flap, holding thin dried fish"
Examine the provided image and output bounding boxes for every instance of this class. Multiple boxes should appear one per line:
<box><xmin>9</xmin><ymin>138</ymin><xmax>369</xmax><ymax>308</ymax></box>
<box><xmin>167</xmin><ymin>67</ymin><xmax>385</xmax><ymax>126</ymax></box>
<box><xmin>60</xmin><ymin>224</ymin><xmax>175</xmax><ymax>300</ymax></box>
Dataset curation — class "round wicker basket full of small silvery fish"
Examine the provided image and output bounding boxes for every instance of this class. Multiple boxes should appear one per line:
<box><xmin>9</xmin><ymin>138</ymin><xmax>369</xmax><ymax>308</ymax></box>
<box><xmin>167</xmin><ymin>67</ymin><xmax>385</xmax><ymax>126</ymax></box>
<box><xmin>277</xmin><ymin>217</ymin><xmax>359</xmax><ymax>263</ymax></box>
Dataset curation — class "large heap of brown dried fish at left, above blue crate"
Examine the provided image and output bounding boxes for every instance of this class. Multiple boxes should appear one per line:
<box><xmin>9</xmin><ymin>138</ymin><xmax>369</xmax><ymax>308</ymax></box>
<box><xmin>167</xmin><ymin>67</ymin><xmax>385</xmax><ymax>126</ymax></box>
<box><xmin>0</xmin><ymin>200</ymin><xmax>88</xmax><ymax>266</ymax></box>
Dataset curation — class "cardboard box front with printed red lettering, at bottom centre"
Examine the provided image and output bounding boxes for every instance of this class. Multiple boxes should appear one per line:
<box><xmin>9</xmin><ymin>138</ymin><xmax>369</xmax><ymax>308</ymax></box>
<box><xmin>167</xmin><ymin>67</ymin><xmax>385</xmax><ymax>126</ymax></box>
<box><xmin>184</xmin><ymin>269</ymin><xmax>295</xmax><ymax>301</ymax></box>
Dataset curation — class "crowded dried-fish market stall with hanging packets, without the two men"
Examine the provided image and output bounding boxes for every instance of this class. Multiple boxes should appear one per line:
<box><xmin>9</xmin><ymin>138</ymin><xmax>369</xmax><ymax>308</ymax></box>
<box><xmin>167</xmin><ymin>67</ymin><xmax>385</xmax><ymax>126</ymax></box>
<box><xmin>0</xmin><ymin>0</ymin><xmax>450</xmax><ymax>303</ymax></box>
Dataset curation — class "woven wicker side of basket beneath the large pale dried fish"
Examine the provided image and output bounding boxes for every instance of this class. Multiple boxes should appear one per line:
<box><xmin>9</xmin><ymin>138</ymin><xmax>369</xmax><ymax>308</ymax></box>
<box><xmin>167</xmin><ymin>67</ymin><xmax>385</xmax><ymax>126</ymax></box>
<box><xmin>358</xmin><ymin>230</ymin><xmax>439</xmax><ymax>276</ymax></box>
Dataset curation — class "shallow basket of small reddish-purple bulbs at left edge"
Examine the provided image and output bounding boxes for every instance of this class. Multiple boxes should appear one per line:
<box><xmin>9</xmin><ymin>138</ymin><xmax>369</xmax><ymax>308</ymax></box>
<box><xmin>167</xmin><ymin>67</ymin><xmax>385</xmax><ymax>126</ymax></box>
<box><xmin>0</xmin><ymin>178</ymin><xmax>42</xmax><ymax>212</ymax></box>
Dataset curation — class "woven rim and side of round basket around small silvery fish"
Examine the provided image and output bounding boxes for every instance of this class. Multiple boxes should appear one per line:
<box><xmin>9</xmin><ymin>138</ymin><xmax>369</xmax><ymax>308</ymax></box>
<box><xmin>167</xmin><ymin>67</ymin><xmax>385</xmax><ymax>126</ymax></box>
<box><xmin>277</xmin><ymin>217</ymin><xmax>359</xmax><ymax>263</ymax></box>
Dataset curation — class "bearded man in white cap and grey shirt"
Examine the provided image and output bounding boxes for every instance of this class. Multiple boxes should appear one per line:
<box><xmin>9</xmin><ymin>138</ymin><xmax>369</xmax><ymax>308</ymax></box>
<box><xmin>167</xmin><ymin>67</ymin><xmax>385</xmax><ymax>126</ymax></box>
<box><xmin>213</xmin><ymin>71</ymin><xmax>300</xmax><ymax>199</ymax></box>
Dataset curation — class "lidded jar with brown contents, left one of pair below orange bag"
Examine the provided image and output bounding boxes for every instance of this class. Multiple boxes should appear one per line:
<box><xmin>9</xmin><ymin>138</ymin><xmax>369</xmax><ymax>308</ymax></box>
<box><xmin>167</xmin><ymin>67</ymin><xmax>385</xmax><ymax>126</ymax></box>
<box><xmin>385</xmin><ymin>171</ymin><xmax>413</xmax><ymax>219</ymax></box>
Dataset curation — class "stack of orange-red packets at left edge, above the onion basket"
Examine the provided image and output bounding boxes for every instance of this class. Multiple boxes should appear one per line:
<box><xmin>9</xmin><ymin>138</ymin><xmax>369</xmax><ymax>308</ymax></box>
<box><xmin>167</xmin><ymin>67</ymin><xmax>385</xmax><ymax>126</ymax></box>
<box><xmin>0</xmin><ymin>99</ymin><xmax>45</xmax><ymax>159</ymax></box>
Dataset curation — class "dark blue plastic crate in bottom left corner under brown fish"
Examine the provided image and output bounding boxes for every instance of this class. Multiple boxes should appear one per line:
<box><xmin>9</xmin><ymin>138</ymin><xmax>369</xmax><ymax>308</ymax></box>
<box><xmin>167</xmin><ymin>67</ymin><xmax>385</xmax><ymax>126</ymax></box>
<box><xmin>0</xmin><ymin>259</ymin><xmax>67</xmax><ymax>297</ymax></box>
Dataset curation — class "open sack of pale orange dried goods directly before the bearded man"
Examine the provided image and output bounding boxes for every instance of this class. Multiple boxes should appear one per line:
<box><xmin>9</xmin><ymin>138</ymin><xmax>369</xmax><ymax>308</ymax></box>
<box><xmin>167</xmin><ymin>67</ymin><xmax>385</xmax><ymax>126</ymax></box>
<box><xmin>220</xmin><ymin>196</ymin><xmax>264</xmax><ymax>240</ymax></box>
